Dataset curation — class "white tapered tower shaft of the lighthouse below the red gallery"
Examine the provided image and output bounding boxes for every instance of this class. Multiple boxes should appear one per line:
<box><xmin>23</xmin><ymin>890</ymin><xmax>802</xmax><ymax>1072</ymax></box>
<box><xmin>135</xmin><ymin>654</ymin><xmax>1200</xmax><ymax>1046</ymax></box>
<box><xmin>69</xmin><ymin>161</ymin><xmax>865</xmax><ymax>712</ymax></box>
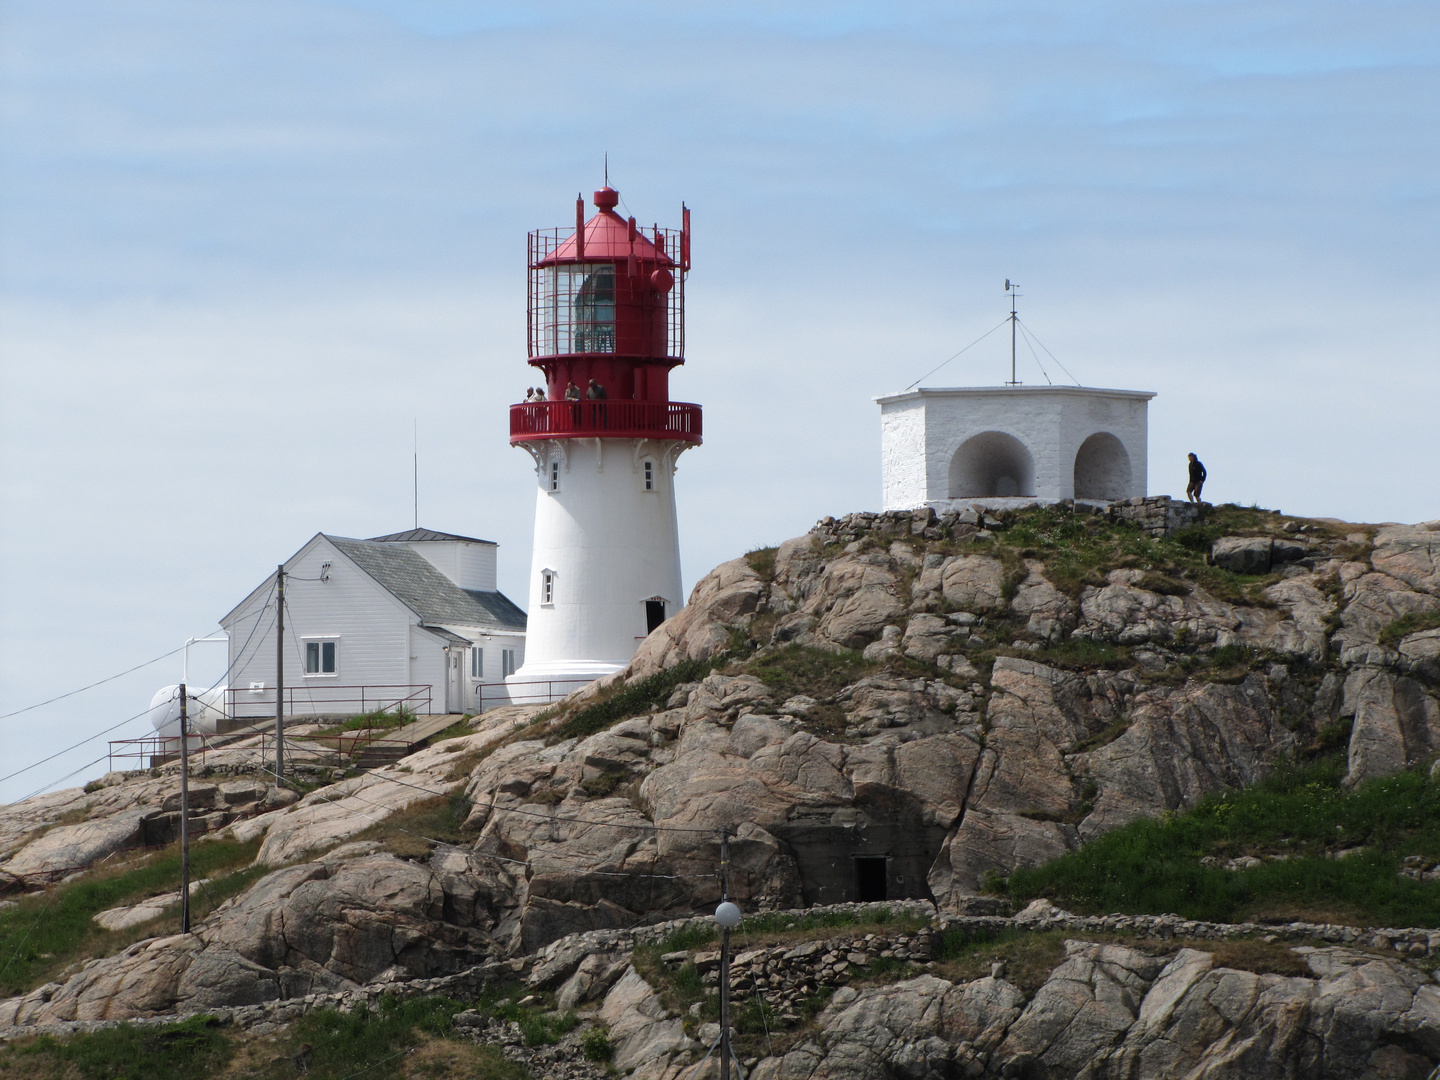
<box><xmin>505</xmin><ymin>439</ymin><xmax>687</xmax><ymax>701</ymax></box>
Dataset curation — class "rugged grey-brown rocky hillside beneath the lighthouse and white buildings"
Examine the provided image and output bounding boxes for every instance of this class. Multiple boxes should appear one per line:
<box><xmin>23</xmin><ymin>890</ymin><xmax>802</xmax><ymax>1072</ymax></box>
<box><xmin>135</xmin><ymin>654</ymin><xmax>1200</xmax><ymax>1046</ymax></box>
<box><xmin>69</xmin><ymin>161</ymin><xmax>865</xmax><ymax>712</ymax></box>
<box><xmin>0</xmin><ymin>501</ymin><xmax>1440</xmax><ymax>1077</ymax></box>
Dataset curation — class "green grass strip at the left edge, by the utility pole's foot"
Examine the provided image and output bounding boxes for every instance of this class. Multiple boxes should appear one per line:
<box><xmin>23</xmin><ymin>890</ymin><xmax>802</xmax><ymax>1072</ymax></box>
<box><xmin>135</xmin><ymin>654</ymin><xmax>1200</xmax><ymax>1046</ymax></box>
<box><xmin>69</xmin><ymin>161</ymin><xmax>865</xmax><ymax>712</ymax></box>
<box><xmin>0</xmin><ymin>840</ymin><xmax>261</xmax><ymax>996</ymax></box>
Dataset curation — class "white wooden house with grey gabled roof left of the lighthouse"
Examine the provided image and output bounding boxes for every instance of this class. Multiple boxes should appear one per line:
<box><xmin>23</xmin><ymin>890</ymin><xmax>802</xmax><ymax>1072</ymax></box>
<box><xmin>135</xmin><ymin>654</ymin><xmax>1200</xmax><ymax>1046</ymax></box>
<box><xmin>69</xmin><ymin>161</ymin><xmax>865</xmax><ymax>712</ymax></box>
<box><xmin>220</xmin><ymin>528</ymin><xmax>526</xmax><ymax>720</ymax></box>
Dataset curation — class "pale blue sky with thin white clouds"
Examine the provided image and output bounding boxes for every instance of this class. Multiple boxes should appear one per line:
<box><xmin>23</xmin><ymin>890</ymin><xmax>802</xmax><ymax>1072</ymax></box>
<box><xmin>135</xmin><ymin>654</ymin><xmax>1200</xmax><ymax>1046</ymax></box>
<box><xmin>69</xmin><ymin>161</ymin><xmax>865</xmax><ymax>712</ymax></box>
<box><xmin>0</xmin><ymin>0</ymin><xmax>1440</xmax><ymax>801</ymax></box>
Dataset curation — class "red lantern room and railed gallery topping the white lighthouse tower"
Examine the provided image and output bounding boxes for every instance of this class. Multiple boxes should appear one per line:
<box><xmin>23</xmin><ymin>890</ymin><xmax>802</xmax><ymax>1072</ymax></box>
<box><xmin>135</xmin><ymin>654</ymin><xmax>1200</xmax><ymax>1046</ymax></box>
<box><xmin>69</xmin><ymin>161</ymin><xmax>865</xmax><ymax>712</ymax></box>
<box><xmin>510</xmin><ymin>186</ymin><xmax>700</xmax><ymax>444</ymax></box>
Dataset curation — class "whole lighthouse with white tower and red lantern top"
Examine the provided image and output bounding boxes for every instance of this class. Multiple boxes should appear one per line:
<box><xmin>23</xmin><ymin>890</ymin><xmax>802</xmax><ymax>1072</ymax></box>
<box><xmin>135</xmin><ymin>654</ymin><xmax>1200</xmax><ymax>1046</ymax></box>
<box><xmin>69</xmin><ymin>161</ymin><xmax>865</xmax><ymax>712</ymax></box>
<box><xmin>505</xmin><ymin>184</ymin><xmax>700</xmax><ymax>703</ymax></box>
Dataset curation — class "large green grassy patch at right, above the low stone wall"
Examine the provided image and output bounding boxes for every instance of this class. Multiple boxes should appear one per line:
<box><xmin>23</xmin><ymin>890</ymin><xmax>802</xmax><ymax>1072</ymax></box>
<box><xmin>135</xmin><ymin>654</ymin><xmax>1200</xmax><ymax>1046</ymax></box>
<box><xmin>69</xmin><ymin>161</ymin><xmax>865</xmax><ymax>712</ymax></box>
<box><xmin>996</xmin><ymin>755</ymin><xmax>1440</xmax><ymax>927</ymax></box>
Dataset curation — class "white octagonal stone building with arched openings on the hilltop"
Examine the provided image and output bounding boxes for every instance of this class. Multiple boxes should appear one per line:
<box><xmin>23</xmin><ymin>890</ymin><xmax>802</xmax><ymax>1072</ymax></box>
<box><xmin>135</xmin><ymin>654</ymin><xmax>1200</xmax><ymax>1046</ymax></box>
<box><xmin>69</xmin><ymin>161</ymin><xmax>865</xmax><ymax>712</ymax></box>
<box><xmin>876</xmin><ymin>386</ymin><xmax>1155</xmax><ymax>510</ymax></box>
